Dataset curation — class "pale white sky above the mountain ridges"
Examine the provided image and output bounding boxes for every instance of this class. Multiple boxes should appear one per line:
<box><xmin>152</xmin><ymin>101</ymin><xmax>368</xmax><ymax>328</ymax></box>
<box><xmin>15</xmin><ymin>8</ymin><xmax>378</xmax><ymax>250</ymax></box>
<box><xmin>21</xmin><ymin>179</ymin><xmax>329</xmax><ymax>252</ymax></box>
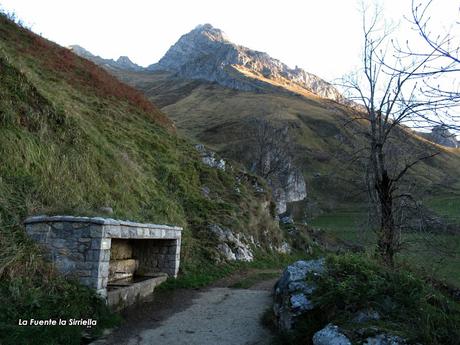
<box><xmin>0</xmin><ymin>0</ymin><xmax>458</xmax><ymax>81</ymax></box>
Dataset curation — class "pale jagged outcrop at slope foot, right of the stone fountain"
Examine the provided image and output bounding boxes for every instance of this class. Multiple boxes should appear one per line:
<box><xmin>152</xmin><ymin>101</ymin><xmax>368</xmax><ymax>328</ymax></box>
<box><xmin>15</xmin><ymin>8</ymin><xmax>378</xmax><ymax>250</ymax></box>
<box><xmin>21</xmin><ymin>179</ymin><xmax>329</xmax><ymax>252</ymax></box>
<box><xmin>208</xmin><ymin>224</ymin><xmax>254</xmax><ymax>262</ymax></box>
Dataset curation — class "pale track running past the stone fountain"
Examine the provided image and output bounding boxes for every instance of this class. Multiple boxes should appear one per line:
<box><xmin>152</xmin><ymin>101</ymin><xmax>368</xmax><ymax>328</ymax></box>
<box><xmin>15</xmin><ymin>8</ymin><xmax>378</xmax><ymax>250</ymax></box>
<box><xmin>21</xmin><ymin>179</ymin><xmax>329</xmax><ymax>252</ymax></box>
<box><xmin>95</xmin><ymin>270</ymin><xmax>278</xmax><ymax>345</ymax></box>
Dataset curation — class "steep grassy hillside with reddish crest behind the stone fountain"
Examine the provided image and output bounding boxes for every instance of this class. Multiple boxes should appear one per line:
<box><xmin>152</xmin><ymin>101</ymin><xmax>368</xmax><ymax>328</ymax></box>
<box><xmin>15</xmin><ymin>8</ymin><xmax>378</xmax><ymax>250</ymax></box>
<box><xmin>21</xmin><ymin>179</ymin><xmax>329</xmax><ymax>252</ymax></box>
<box><xmin>0</xmin><ymin>15</ymin><xmax>292</xmax><ymax>344</ymax></box>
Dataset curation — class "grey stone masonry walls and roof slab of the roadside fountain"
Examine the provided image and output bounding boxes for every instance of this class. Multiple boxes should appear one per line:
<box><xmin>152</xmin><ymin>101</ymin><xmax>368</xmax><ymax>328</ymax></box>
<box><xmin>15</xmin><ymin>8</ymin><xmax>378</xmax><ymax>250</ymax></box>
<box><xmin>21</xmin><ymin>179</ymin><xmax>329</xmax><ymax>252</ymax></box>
<box><xmin>25</xmin><ymin>216</ymin><xmax>182</xmax><ymax>296</ymax></box>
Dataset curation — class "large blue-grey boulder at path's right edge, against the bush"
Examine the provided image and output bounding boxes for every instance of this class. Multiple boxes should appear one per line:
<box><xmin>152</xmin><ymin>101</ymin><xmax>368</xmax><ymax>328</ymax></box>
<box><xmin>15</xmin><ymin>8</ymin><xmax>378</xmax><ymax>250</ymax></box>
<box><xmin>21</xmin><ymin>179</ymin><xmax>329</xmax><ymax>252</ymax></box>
<box><xmin>273</xmin><ymin>259</ymin><xmax>324</xmax><ymax>330</ymax></box>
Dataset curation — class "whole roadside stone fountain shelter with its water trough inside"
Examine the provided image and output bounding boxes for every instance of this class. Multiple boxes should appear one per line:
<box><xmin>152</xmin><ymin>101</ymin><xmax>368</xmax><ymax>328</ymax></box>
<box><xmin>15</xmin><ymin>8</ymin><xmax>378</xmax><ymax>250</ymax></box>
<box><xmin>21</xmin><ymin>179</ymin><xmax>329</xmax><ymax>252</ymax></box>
<box><xmin>25</xmin><ymin>216</ymin><xmax>182</xmax><ymax>309</ymax></box>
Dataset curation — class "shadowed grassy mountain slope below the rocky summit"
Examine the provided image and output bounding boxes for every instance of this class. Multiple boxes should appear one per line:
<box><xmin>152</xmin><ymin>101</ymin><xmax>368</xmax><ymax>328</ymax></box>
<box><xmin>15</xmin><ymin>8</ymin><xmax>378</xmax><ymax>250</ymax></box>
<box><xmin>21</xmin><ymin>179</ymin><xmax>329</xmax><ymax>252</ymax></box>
<box><xmin>113</xmin><ymin>71</ymin><xmax>460</xmax><ymax>208</ymax></box>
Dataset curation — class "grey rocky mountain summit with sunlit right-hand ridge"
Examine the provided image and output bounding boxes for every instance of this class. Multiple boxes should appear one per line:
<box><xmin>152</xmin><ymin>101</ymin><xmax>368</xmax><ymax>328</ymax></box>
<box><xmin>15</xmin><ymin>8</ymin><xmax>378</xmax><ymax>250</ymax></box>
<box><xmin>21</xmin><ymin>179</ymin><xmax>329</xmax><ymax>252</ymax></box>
<box><xmin>148</xmin><ymin>24</ymin><xmax>347</xmax><ymax>102</ymax></box>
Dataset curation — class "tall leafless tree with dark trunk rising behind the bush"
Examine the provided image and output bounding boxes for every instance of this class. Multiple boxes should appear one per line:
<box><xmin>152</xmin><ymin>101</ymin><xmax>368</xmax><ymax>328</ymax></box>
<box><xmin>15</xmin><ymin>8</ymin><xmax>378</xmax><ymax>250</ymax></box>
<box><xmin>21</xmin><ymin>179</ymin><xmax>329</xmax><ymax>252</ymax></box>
<box><xmin>343</xmin><ymin>4</ymin><xmax>456</xmax><ymax>266</ymax></box>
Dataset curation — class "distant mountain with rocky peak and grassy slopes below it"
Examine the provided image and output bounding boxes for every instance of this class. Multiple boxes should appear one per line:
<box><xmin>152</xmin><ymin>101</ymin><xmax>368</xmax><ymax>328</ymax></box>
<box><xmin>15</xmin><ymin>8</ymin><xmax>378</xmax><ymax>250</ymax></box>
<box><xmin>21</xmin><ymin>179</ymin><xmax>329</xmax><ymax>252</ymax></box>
<box><xmin>73</xmin><ymin>24</ymin><xmax>460</xmax><ymax>214</ymax></box>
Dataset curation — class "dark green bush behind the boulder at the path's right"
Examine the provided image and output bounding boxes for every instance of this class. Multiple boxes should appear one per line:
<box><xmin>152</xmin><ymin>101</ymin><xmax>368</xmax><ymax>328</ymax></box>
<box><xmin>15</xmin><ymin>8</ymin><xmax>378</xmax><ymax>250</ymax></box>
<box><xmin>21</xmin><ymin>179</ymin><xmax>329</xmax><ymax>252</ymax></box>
<box><xmin>309</xmin><ymin>254</ymin><xmax>460</xmax><ymax>345</ymax></box>
